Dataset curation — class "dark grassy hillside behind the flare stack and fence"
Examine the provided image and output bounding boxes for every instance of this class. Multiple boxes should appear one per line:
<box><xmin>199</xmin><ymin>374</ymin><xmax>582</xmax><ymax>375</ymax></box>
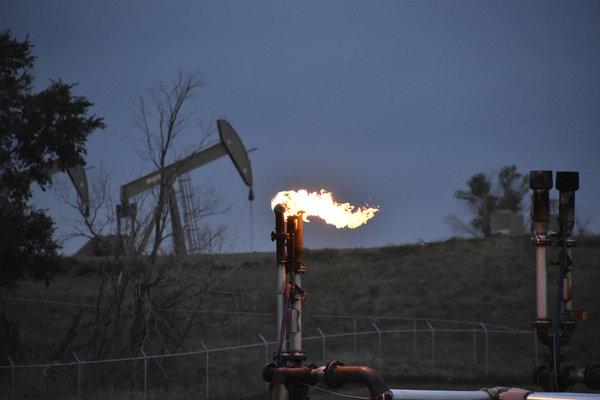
<box><xmin>0</xmin><ymin>236</ymin><xmax>600</xmax><ymax>399</ymax></box>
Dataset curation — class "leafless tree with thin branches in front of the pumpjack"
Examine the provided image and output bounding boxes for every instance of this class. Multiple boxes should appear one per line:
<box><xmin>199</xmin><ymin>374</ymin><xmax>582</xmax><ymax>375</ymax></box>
<box><xmin>49</xmin><ymin>72</ymin><xmax>238</xmax><ymax>358</ymax></box>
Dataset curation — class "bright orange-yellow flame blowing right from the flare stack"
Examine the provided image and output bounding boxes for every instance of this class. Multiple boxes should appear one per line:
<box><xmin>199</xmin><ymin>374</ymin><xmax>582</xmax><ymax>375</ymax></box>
<box><xmin>271</xmin><ymin>189</ymin><xmax>379</xmax><ymax>228</ymax></box>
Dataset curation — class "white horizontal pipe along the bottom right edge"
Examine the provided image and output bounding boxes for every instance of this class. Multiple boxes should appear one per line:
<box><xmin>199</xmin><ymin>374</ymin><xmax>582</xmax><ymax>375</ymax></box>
<box><xmin>389</xmin><ymin>389</ymin><xmax>600</xmax><ymax>400</ymax></box>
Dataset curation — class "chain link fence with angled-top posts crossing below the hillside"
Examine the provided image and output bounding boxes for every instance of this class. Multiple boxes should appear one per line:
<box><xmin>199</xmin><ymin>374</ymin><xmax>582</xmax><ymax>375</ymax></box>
<box><xmin>0</xmin><ymin>312</ymin><xmax>538</xmax><ymax>400</ymax></box>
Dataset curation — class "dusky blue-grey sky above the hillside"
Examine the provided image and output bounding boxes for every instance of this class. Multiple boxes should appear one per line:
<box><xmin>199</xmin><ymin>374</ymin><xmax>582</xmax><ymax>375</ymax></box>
<box><xmin>0</xmin><ymin>0</ymin><xmax>600</xmax><ymax>254</ymax></box>
